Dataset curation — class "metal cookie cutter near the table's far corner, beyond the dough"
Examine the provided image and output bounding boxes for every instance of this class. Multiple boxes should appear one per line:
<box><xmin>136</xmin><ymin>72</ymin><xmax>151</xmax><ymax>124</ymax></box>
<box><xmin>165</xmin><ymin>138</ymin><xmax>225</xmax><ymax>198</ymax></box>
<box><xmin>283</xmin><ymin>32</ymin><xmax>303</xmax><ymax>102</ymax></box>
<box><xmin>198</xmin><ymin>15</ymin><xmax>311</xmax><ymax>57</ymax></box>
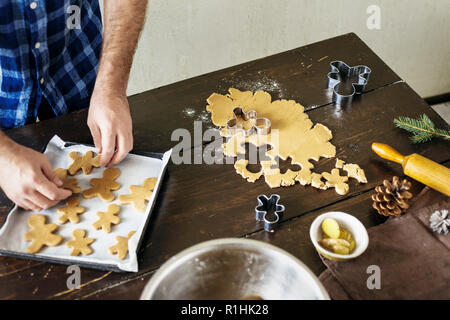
<box><xmin>327</xmin><ymin>61</ymin><xmax>372</xmax><ymax>104</ymax></box>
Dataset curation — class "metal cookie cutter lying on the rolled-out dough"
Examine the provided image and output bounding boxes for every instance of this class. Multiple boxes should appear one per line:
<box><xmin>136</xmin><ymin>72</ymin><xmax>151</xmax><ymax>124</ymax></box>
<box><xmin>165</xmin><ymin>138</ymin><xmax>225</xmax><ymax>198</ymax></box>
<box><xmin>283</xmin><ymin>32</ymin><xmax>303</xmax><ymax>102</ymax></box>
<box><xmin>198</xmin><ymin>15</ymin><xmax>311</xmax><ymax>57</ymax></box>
<box><xmin>227</xmin><ymin>107</ymin><xmax>271</xmax><ymax>137</ymax></box>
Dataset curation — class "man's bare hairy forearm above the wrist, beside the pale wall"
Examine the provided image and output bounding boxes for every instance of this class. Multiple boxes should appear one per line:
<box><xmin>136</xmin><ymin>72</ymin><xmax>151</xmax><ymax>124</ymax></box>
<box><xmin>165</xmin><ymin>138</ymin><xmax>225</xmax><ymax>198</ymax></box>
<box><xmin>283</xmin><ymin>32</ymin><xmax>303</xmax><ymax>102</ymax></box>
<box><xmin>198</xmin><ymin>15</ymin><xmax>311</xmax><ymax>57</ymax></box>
<box><xmin>95</xmin><ymin>0</ymin><xmax>148</xmax><ymax>94</ymax></box>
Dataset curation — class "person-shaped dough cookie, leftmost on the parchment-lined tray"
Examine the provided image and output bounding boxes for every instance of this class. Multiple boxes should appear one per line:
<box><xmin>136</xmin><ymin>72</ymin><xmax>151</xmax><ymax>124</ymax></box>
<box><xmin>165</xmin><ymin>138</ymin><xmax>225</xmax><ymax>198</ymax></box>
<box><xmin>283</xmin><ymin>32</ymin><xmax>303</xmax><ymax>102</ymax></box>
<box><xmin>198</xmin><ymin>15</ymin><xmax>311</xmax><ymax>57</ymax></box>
<box><xmin>25</xmin><ymin>214</ymin><xmax>63</xmax><ymax>253</ymax></box>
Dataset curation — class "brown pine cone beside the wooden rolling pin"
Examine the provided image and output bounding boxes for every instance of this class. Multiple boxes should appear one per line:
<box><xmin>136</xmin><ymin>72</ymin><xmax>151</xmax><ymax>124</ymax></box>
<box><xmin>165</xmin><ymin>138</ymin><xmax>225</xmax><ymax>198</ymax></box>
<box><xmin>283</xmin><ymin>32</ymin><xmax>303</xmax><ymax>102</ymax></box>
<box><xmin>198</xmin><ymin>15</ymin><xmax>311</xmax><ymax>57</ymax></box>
<box><xmin>372</xmin><ymin>176</ymin><xmax>412</xmax><ymax>216</ymax></box>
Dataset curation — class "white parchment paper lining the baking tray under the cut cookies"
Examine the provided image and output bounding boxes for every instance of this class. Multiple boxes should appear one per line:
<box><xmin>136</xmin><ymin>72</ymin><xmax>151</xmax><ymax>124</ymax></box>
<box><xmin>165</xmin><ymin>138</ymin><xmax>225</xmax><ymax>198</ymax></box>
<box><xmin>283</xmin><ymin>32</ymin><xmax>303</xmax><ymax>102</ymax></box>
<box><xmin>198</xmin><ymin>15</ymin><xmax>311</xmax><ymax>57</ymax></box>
<box><xmin>0</xmin><ymin>136</ymin><xmax>172</xmax><ymax>272</ymax></box>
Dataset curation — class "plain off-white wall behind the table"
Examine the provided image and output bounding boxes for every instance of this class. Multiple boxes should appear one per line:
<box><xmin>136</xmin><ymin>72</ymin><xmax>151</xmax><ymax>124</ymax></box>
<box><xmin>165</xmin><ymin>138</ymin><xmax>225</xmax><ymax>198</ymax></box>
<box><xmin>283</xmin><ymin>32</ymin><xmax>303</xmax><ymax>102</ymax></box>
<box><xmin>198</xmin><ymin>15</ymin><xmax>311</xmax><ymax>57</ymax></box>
<box><xmin>108</xmin><ymin>0</ymin><xmax>450</xmax><ymax>97</ymax></box>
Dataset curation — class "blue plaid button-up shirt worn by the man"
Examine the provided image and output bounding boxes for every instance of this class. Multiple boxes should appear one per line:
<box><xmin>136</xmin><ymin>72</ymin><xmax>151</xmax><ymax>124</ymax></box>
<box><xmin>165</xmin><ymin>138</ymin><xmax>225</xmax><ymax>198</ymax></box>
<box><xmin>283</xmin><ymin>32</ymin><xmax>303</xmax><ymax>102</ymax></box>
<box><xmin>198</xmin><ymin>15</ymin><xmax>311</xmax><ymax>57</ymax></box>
<box><xmin>0</xmin><ymin>0</ymin><xmax>102</xmax><ymax>128</ymax></box>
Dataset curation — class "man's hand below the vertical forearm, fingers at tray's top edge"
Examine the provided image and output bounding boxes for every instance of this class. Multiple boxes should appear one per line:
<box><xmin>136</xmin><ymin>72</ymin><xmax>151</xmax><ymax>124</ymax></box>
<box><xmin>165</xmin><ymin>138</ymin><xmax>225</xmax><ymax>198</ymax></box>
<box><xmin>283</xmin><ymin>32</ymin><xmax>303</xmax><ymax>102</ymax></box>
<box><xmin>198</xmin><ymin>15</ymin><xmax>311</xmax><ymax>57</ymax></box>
<box><xmin>87</xmin><ymin>88</ymin><xmax>133</xmax><ymax>167</ymax></box>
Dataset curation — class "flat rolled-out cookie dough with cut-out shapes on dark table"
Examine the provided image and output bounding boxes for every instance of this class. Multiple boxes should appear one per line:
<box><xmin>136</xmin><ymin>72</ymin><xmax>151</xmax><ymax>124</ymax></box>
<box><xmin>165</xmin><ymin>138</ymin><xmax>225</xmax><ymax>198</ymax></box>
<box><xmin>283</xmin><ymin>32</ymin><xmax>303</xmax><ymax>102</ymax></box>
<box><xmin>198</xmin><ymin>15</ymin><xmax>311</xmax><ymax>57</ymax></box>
<box><xmin>206</xmin><ymin>88</ymin><xmax>368</xmax><ymax>196</ymax></box>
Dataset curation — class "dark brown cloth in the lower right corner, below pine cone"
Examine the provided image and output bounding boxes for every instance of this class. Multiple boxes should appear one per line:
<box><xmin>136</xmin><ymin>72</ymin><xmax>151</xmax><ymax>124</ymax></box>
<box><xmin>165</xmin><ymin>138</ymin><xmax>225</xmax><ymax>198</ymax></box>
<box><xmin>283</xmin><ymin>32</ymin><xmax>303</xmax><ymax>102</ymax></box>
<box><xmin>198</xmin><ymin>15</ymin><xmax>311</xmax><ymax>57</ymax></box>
<box><xmin>319</xmin><ymin>188</ymin><xmax>450</xmax><ymax>300</ymax></box>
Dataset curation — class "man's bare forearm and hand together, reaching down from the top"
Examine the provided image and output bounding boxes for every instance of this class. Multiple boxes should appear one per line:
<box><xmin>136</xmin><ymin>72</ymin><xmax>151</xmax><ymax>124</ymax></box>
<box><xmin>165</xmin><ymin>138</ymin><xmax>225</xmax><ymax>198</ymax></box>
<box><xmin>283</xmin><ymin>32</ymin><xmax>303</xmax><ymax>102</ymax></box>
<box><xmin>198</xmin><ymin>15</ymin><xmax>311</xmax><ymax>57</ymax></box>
<box><xmin>88</xmin><ymin>0</ymin><xmax>148</xmax><ymax>167</ymax></box>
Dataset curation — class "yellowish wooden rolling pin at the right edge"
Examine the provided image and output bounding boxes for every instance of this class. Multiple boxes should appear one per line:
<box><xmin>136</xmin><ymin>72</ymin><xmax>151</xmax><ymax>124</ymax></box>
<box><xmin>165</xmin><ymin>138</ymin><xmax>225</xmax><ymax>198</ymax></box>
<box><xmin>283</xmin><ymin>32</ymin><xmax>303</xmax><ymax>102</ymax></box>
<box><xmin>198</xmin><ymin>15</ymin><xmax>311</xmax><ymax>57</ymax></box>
<box><xmin>372</xmin><ymin>142</ymin><xmax>450</xmax><ymax>197</ymax></box>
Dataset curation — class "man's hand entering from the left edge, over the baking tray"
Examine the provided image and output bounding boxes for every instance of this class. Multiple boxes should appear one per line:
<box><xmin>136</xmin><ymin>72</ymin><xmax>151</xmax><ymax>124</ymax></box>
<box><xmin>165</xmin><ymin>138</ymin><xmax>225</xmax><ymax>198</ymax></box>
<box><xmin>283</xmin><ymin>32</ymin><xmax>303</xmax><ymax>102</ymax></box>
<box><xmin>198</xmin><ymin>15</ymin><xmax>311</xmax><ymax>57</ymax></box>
<box><xmin>0</xmin><ymin>139</ymin><xmax>72</xmax><ymax>211</ymax></box>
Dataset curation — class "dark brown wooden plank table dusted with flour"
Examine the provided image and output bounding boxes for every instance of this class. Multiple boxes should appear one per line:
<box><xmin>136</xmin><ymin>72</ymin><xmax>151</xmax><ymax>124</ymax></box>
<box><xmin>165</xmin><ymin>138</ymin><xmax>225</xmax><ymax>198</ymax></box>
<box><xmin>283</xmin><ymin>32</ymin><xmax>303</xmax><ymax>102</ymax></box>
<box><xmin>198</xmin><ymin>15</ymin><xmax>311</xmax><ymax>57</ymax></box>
<box><xmin>0</xmin><ymin>33</ymin><xmax>450</xmax><ymax>299</ymax></box>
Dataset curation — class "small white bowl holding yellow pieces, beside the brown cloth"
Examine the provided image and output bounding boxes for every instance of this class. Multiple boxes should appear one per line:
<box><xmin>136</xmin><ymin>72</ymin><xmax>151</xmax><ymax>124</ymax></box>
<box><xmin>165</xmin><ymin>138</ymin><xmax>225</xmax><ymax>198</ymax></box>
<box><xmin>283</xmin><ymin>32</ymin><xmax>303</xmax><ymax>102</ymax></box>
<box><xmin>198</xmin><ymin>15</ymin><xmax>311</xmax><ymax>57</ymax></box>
<box><xmin>309</xmin><ymin>211</ymin><xmax>369</xmax><ymax>261</ymax></box>
